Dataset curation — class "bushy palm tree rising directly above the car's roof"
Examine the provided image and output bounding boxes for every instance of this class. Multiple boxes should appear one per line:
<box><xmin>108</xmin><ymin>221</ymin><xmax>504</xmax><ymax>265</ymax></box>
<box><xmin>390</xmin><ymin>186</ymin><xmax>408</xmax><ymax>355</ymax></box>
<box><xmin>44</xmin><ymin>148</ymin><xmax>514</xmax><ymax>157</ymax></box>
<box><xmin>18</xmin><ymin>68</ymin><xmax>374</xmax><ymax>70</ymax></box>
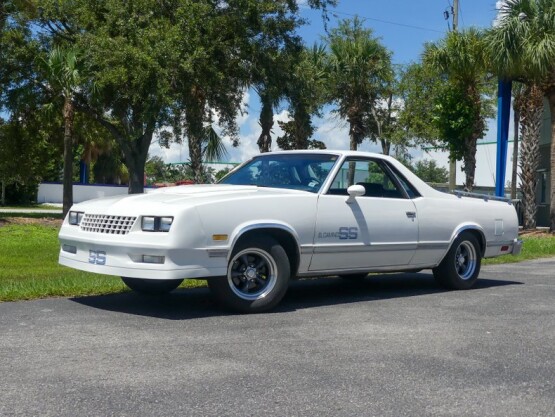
<box><xmin>327</xmin><ymin>17</ymin><xmax>393</xmax><ymax>150</ymax></box>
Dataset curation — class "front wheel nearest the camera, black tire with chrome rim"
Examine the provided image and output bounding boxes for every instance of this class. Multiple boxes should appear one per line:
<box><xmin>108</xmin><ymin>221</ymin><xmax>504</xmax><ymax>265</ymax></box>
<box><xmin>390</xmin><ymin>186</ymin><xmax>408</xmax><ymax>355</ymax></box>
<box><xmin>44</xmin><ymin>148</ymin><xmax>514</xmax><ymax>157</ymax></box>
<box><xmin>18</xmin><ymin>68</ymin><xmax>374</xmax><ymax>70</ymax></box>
<box><xmin>208</xmin><ymin>236</ymin><xmax>291</xmax><ymax>313</ymax></box>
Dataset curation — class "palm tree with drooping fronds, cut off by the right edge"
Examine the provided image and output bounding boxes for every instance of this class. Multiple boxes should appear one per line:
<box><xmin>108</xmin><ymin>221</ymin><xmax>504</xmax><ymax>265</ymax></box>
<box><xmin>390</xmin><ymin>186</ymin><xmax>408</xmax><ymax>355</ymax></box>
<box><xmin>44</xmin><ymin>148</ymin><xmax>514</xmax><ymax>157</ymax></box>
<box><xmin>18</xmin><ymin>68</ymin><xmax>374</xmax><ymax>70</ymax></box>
<box><xmin>488</xmin><ymin>0</ymin><xmax>555</xmax><ymax>231</ymax></box>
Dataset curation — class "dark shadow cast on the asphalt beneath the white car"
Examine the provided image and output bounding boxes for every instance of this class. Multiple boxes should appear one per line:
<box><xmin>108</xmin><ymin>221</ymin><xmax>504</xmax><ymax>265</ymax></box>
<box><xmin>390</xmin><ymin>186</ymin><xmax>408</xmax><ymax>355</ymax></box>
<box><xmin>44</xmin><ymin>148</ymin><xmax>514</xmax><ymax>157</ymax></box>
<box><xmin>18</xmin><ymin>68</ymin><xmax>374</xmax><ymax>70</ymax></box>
<box><xmin>72</xmin><ymin>272</ymin><xmax>522</xmax><ymax>320</ymax></box>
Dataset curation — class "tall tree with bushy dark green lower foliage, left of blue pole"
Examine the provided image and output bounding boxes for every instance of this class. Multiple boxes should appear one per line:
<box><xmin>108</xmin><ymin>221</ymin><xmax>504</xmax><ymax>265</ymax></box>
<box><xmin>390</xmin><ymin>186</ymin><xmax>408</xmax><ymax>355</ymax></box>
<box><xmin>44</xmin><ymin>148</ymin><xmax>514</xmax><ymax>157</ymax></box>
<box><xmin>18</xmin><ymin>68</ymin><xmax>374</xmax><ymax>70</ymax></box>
<box><xmin>423</xmin><ymin>28</ymin><xmax>493</xmax><ymax>190</ymax></box>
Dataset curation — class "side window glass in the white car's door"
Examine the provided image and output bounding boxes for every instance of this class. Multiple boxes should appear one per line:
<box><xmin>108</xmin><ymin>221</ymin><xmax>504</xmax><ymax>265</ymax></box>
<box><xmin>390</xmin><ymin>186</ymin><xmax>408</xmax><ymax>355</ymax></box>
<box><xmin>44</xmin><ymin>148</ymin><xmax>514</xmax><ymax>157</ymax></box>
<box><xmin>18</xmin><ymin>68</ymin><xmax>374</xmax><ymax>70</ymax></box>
<box><xmin>328</xmin><ymin>159</ymin><xmax>404</xmax><ymax>198</ymax></box>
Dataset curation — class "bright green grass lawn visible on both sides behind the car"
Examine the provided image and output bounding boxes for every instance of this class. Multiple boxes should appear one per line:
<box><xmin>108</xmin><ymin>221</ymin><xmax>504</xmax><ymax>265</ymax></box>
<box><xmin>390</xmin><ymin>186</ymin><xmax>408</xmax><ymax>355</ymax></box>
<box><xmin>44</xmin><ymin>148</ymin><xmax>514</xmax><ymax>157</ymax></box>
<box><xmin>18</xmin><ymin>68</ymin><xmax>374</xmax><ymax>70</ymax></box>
<box><xmin>0</xmin><ymin>218</ymin><xmax>555</xmax><ymax>301</ymax></box>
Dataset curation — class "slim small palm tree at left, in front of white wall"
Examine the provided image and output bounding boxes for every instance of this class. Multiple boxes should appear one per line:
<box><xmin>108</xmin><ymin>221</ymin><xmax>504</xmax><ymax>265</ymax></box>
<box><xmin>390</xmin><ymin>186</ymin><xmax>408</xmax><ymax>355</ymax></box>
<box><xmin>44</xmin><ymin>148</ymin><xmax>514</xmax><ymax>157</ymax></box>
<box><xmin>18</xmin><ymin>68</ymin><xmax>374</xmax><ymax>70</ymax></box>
<box><xmin>41</xmin><ymin>47</ymin><xmax>81</xmax><ymax>216</ymax></box>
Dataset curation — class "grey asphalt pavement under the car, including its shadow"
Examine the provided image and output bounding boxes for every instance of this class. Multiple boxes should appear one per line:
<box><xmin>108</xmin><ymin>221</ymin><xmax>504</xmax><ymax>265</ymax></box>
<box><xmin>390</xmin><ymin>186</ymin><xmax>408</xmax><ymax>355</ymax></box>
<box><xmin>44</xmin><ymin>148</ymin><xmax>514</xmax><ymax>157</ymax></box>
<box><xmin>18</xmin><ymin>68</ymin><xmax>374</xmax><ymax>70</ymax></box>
<box><xmin>0</xmin><ymin>259</ymin><xmax>555</xmax><ymax>417</ymax></box>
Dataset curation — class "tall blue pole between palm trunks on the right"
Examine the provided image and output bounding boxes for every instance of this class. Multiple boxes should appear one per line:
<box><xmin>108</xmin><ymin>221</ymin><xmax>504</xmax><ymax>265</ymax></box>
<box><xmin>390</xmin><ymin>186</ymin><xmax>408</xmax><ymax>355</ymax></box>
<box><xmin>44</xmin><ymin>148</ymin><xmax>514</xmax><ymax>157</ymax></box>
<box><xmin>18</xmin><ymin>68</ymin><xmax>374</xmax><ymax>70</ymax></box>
<box><xmin>495</xmin><ymin>80</ymin><xmax>512</xmax><ymax>197</ymax></box>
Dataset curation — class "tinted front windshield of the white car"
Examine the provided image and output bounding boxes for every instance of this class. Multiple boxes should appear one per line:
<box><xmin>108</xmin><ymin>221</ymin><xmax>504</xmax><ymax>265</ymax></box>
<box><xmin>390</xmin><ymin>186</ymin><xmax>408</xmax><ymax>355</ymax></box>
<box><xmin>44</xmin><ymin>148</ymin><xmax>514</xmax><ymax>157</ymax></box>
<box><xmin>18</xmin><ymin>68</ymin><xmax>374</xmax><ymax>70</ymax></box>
<box><xmin>219</xmin><ymin>153</ymin><xmax>338</xmax><ymax>193</ymax></box>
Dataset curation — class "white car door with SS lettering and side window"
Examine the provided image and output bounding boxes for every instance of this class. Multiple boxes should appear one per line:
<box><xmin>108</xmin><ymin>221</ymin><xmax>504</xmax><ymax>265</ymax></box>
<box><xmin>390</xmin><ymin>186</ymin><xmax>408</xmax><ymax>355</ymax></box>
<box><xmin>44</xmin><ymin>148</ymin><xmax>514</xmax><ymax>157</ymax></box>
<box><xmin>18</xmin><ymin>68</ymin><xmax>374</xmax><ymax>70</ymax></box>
<box><xmin>309</xmin><ymin>157</ymin><xmax>418</xmax><ymax>271</ymax></box>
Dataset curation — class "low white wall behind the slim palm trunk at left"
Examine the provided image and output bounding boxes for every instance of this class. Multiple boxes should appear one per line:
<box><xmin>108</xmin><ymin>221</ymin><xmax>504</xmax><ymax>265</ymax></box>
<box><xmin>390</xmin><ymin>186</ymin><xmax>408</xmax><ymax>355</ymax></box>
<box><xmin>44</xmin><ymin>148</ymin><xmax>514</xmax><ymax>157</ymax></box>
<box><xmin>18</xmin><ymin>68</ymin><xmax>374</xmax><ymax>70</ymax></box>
<box><xmin>37</xmin><ymin>183</ymin><xmax>154</xmax><ymax>204</ymax></box>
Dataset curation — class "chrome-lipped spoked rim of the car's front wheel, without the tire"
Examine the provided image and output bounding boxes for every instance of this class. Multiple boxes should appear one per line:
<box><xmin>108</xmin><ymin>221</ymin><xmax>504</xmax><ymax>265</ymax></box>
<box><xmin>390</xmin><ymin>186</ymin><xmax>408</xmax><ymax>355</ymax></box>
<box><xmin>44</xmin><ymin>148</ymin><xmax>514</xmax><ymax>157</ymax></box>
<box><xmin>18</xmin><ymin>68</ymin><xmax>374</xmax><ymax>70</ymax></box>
<box><xmin>227</xmin><ymin>248</ymin><xmax>278</xmax><ymax>301</ymax></box>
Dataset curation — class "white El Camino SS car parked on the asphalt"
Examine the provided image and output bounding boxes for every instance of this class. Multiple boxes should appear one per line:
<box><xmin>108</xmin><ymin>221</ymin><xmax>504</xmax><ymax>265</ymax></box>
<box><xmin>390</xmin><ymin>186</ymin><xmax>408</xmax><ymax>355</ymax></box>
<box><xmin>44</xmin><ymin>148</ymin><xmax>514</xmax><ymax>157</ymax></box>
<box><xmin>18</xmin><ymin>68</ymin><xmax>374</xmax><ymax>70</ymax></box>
<box><xmin>59</xmin><ymin>151</ymin><xmax>522</xmax><ymax>312</ymax></box>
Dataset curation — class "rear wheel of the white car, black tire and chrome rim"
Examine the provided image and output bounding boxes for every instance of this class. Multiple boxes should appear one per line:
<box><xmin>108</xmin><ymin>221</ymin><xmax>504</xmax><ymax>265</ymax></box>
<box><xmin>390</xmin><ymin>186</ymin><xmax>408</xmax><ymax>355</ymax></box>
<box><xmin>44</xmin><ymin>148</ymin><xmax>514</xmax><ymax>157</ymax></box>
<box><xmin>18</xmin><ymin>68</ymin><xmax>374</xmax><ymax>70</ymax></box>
<box><xmin>433</xmin><ymin>232</ymin><xmax>482</xmax><ymax>290</ymax></box>
